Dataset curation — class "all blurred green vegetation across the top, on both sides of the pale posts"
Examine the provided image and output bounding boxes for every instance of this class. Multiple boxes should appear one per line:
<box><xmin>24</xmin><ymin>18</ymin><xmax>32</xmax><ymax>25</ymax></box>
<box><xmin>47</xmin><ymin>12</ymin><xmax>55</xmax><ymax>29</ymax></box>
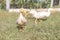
<box><xmin>0</xmin><ymin>0</ymin><xmax>58</xmax><ymax>9</ymax></box>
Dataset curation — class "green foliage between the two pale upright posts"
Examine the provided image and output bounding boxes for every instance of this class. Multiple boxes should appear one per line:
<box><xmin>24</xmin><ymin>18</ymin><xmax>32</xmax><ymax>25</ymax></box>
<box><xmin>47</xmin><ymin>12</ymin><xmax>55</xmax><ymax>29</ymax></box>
<box><xmin>10</xmin><ymin>0</ymin><xmax>50</xmax><ymax>8</ymax></box>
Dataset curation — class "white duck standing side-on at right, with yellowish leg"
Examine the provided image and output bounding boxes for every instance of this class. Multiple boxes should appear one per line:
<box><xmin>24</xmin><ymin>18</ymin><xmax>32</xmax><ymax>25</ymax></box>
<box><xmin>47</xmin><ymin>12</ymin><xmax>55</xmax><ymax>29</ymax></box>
<box><xmin>30</xmin><ymin>8</ymin><xmax>51</xmax><ymax>24</ymax></box>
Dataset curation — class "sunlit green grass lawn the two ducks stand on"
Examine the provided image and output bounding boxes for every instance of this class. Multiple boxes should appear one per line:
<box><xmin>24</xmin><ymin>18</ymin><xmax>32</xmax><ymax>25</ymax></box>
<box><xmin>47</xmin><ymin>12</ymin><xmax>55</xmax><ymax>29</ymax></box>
<box><xmin>0</xmin><ymin>11</ymin><xmax>60</xmax><ymax>40</ymax></box>
